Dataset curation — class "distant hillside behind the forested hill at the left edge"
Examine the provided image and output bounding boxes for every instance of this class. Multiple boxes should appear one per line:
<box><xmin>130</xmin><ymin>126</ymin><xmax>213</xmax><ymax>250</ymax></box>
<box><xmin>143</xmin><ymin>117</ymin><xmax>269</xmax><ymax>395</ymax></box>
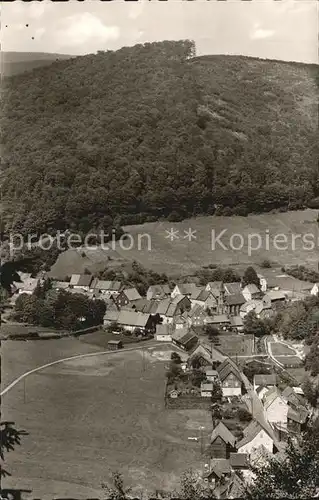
<box><xmin>0</xmin><ymin>52</ymin><xmax>72</xmax><ymax>77</ymax></box>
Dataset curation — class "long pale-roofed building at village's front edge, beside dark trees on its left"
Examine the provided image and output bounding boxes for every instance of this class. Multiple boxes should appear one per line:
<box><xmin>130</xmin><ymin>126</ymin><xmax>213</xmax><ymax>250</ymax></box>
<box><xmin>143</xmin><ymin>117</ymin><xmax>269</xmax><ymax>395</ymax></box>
<box><xmin>103</xmin><ymin>309</ymin><xmax>154</xmax><ymax>333</ymax></box>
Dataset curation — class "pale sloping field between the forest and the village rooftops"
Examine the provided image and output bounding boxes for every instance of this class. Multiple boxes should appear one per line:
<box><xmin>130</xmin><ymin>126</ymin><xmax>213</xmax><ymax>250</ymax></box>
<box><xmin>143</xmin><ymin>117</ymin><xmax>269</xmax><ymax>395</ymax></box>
<box><xmin>51</xmin><ymin>210</ymin><xmax>318</xmax><ymax>276</ymax></box>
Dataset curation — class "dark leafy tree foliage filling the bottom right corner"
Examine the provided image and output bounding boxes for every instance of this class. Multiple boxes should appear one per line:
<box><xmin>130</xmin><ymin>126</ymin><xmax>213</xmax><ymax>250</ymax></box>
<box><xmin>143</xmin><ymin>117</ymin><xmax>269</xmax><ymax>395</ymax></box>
<box><xmin>245</xmin><ymin>419</ymin><xmax>319</xmax><ymax>500</ymax></box>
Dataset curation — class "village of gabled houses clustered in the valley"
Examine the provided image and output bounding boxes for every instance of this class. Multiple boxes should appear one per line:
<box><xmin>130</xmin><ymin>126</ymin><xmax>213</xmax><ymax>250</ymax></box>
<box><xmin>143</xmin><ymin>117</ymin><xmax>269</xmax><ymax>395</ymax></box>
<box><xmin>4</xmin><ymin>264</ymin><xmax>319</xmax><ymax>498</ymax></box>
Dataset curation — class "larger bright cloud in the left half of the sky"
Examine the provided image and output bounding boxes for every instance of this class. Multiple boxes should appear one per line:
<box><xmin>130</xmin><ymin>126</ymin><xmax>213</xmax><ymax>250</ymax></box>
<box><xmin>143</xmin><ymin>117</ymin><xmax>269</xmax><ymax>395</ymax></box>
<box><xmin>56</xmin><ymin>12</ymin><xmax>120</xmax><ymax>47</ymax></box>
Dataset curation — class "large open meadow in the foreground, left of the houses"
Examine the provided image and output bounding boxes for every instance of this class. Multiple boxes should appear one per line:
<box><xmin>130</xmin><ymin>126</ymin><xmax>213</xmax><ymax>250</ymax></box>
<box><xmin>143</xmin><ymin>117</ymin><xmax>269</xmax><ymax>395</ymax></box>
<box><xmin>2</xmin><ymin>339</ymin><xmax>212</xmax><ymax>499</ymax></box>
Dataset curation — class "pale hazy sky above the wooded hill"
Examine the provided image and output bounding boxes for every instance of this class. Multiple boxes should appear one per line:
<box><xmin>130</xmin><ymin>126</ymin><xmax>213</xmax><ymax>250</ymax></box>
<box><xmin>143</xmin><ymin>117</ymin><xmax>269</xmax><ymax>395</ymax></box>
<box><xmin>1</xmin><ymin>0</ymin><xmax>319</xmax><ymax>63</ymax></box>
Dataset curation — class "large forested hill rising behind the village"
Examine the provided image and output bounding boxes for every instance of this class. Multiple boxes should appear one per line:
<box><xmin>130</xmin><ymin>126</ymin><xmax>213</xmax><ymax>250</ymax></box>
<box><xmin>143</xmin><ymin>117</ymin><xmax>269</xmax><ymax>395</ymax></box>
<box><xmin>1</xmin><ymin>41</ymin><xmax>319</xmax><ymax>232</ymax></box>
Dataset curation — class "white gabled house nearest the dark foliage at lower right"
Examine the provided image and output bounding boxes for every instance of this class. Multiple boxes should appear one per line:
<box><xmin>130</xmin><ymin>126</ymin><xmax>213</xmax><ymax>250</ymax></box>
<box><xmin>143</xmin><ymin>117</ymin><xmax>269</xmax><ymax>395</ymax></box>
<box><xmin>237</xmin><ymin>420</ymin><xmax>276</xmax><ymax>456</ymax></box>
